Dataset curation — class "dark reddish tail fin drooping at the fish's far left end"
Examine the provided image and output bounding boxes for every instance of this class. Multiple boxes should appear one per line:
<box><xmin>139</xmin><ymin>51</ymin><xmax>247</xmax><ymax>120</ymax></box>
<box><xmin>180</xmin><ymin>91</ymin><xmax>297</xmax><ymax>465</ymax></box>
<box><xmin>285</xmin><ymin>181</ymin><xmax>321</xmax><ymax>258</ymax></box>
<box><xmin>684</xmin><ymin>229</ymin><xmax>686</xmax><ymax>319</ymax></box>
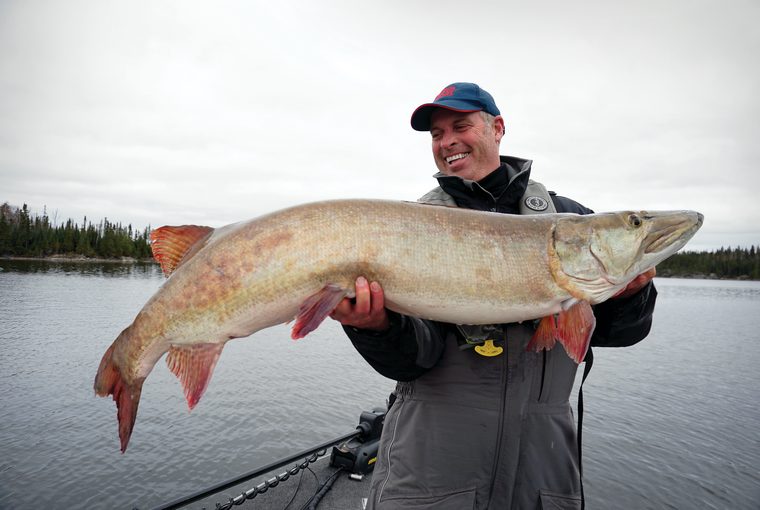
<box><xmin>95</xmin><ymin>345</ymin><xmax>144</xmax><ymax>453</ymax></box>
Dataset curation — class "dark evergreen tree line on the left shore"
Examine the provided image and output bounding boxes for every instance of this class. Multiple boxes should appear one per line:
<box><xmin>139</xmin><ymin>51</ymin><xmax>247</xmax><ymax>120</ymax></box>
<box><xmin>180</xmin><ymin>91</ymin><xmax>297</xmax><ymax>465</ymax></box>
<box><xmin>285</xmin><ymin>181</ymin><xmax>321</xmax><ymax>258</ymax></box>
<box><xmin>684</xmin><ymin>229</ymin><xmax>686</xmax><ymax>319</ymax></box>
<box><xmin>0</xmin><ymin>202</ymin><xmax>152</xmax><ymax>259</ymax></box>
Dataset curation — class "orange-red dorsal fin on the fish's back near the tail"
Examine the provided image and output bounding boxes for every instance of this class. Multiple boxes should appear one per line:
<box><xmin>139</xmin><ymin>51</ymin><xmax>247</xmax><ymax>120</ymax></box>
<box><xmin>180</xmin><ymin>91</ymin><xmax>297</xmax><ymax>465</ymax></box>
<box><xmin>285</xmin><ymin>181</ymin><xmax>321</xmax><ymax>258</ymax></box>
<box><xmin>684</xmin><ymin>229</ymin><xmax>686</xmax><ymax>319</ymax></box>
<box><xmin>150</xmin><ymin>225</ymin><xmax>214</xmax><ymax>278</ymax></box>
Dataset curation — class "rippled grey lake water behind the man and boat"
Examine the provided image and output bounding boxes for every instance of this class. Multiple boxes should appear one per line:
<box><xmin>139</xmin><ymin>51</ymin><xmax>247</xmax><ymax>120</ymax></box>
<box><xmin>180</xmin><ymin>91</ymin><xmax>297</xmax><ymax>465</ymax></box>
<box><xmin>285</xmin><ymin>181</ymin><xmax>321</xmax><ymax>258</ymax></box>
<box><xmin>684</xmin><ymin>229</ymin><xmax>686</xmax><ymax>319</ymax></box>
<box><xmin>0</xmin><ymin>260</ymin><xmax>760</xmax><ymax>510</ymax></box>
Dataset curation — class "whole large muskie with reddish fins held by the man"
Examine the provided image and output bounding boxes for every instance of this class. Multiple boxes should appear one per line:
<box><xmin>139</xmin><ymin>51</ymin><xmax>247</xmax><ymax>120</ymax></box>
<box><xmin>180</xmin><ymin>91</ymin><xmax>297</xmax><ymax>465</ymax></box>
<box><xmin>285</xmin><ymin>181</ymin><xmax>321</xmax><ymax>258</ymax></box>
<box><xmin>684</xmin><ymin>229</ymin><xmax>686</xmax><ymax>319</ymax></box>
<box><xmin>95</xmin><ymin>200</ymin><xmax>702</xmax><ymax>451</ymax></box>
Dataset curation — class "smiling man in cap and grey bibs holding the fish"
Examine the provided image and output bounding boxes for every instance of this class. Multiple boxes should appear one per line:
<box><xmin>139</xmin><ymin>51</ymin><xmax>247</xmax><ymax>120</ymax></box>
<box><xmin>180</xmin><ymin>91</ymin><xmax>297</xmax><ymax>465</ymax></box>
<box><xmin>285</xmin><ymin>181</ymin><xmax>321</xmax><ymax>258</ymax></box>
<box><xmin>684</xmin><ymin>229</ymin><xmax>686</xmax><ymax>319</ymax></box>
<box><xmin>331</xmin><ymin>83</ymin><xmax>657</xmax><ymax>510</ymax></box>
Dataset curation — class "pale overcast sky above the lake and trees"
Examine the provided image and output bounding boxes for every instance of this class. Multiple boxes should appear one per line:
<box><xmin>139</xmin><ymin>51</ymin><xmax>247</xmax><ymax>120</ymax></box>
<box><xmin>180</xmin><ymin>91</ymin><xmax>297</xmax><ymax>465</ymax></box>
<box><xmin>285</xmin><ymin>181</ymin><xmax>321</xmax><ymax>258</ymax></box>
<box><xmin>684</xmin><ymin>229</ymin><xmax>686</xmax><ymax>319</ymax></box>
<box><xmin>0</xmin><ymin>0</ymin><xmax>760</xmax><ymax>250</ymax></box>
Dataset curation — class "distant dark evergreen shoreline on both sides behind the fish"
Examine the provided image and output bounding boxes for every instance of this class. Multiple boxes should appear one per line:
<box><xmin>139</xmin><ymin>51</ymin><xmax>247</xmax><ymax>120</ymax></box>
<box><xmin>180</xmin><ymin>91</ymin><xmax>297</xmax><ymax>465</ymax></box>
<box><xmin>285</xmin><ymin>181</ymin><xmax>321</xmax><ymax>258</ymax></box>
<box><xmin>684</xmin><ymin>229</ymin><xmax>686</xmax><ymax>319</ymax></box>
<box><xmin>0</xmin><ymin>202</ymin><xmax>760</xmax><ymax>280</ymax></box>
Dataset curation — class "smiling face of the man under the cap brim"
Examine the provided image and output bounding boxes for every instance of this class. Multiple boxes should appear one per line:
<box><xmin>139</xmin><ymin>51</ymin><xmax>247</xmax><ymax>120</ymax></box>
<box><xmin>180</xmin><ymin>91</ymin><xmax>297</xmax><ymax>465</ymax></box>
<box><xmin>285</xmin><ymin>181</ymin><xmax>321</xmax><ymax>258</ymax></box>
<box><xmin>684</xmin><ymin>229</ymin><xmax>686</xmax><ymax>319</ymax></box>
<box><xmin>430</xmin><ymin>108</ymin><xmax>504</xmax><ymax>181</ymax></box>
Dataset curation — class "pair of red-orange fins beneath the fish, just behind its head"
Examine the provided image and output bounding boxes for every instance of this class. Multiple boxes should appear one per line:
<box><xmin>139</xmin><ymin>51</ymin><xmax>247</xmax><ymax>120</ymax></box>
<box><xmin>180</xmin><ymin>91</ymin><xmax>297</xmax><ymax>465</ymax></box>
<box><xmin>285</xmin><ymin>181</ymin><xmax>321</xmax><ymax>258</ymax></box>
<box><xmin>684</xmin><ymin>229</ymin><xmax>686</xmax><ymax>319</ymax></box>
<box><xmin>526</xmin><ymin>301</ymin><xmax>596</xmax><ymax>364</ymax></box>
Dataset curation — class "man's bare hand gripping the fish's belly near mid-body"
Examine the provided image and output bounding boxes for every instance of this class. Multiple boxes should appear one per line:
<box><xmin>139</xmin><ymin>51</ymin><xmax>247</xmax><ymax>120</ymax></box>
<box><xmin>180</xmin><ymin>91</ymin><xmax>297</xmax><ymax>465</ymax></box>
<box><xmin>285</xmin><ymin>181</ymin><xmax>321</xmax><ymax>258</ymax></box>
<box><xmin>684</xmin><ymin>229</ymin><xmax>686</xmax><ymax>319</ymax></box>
<box><xmin>330</xmin><ymin>276</ymin><xmax>391</xmax><ymax>331</ymax></box>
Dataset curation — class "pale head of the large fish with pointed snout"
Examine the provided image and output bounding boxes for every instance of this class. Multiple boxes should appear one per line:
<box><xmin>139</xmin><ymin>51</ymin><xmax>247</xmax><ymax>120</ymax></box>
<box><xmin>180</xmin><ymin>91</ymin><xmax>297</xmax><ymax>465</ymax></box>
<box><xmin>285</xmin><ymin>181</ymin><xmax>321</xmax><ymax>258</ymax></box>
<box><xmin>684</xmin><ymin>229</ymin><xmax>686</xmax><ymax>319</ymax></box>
<box><xmin>553</xmin><ymin>211</ymin><xmax>703</xmax><ymax>304</ymax></box>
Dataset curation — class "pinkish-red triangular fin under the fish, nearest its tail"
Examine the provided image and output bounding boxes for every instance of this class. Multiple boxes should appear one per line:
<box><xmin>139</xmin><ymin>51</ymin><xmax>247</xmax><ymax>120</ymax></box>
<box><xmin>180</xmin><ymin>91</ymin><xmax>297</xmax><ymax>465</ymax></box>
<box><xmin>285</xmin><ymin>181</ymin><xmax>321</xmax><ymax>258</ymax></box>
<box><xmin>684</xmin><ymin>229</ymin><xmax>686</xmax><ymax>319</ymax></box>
<box><xmin>166</xmin><ymin>343</ymin><xmax>224</xmax><ymax>410</ymax></box>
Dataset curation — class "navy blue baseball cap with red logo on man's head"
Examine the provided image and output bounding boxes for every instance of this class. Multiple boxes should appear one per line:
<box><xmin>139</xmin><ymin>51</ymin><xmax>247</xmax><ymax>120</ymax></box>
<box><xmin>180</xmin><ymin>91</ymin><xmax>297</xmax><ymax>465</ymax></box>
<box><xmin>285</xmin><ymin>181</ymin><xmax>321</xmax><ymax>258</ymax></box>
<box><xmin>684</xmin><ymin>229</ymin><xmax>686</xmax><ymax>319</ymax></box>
<box><xmin>412</xmin><ymin>82</ymin><xmax>501</xmax><ymax>131</ymax></box>
